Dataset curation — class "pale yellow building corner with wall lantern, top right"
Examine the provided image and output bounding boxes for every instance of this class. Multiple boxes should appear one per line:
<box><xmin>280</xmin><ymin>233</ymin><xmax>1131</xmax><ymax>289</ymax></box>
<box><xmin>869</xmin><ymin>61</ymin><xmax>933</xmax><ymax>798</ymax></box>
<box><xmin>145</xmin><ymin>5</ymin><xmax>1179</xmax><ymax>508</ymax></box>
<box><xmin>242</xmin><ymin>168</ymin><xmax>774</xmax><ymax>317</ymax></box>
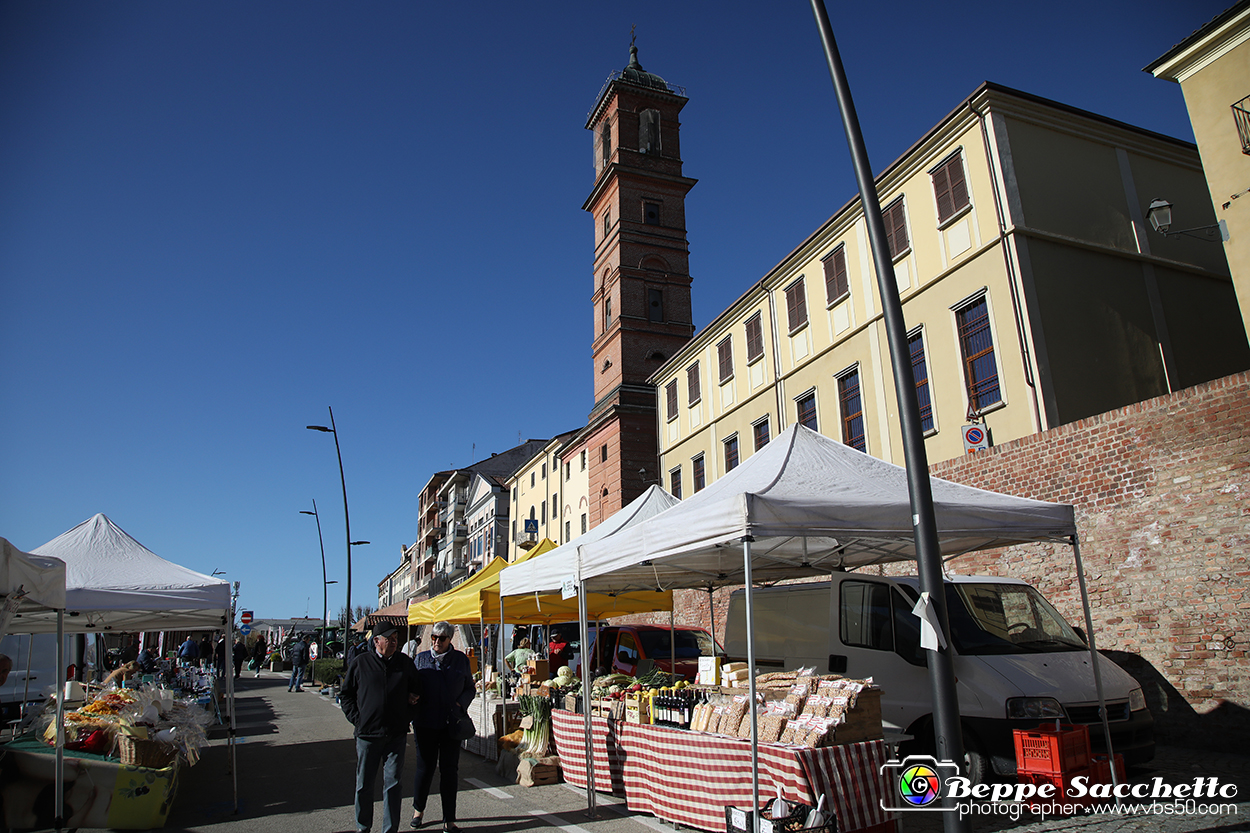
<box><xmin>1145</xmin><ymin>0</ymin><xmax>1250</xmax><ymax>331</ymax></box>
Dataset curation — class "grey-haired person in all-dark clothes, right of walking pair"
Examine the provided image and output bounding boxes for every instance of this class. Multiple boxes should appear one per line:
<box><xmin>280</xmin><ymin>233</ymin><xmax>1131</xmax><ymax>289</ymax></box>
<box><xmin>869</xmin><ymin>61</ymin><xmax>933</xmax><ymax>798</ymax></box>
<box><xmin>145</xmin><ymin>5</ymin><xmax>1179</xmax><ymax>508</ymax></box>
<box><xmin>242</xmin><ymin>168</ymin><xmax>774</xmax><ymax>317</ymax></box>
<box><xmin>411</xmin><ymin>622</ymin><xmax>475</xmax><ymax>833</ymax></box>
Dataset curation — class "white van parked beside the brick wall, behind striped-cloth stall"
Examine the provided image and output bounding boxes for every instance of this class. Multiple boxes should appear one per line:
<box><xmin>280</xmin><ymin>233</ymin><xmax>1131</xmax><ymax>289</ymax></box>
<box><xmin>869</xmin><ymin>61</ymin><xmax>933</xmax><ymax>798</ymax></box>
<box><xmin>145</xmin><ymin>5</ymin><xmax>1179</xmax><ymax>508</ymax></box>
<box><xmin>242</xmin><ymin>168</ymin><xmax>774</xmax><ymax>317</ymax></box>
<box><xmin>725</xmin><ymin>573</ymin><xmax>1155</xmax><ymax>780</ymax></box>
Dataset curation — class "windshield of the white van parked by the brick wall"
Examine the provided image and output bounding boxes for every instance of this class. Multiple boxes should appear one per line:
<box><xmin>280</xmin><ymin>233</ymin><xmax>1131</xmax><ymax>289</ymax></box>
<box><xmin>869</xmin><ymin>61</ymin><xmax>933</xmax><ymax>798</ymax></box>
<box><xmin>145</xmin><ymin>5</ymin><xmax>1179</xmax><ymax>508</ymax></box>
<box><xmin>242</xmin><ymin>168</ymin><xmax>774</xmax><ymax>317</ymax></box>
<box><xmin>946</xmin><ymin>583</ymin><xmax>1088</xmax><ymax>657</ymax></box>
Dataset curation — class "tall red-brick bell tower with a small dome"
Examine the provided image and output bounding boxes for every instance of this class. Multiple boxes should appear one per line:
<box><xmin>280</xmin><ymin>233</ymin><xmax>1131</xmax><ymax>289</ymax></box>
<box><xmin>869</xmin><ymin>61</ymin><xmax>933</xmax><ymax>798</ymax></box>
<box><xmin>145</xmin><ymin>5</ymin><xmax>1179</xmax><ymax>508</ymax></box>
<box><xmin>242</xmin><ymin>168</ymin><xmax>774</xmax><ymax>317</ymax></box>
<box><xmin>566</xmin><ymin>44</ymin><xmax>696</xmax><ymax>527</ymax></box>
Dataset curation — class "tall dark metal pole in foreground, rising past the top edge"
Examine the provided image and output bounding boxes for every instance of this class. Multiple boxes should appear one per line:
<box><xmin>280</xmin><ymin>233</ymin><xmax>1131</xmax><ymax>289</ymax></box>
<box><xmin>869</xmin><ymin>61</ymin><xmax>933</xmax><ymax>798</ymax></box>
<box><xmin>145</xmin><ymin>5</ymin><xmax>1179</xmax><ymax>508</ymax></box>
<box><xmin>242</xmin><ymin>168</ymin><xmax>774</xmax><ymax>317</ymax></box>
<box><xmin>811</xmin><ymin>0</ymin><xmax>971</xmax><ymax>830</ymax></box>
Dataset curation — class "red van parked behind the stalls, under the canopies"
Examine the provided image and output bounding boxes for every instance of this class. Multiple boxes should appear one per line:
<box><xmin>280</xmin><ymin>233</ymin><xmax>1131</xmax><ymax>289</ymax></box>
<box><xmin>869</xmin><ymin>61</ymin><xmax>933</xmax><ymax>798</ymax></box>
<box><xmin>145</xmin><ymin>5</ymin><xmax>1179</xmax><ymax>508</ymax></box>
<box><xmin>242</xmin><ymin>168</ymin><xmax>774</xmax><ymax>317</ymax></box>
<box><xmin>580</xmin><ymin>625</ymin><xmax>725</xmax><ymax>679</ymax></box>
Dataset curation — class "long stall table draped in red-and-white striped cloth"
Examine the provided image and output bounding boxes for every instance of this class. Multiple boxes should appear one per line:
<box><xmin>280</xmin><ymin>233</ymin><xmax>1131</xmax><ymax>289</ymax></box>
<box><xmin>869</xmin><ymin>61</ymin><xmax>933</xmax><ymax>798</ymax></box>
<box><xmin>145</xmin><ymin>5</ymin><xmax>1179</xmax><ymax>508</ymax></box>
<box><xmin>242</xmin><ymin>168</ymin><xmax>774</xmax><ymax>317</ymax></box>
<box><xmin>551</xmin><ymin>710</ymin><xmax>895</xmax><ymax>833</ymax></box>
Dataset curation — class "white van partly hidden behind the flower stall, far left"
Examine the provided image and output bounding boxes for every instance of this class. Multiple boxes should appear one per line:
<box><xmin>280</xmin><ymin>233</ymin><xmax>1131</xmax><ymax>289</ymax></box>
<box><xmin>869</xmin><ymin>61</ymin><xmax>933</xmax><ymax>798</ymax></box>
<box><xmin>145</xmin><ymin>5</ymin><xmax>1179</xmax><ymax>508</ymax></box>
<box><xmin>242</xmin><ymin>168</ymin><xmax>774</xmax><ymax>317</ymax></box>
<box><xmin>0</xmin><ymin>633</ymin><xmax>101</xmax><ymax>722</ymax></box>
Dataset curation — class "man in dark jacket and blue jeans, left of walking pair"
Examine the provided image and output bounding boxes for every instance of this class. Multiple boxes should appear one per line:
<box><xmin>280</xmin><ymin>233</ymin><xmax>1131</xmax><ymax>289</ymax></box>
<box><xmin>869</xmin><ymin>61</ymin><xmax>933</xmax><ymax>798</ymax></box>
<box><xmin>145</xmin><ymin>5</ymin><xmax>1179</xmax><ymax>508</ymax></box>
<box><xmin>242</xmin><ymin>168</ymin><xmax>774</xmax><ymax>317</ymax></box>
<box><xmin>339</xmin><ymin>625</ymin><xmax>421</xmax><ymax>833</ymax></box>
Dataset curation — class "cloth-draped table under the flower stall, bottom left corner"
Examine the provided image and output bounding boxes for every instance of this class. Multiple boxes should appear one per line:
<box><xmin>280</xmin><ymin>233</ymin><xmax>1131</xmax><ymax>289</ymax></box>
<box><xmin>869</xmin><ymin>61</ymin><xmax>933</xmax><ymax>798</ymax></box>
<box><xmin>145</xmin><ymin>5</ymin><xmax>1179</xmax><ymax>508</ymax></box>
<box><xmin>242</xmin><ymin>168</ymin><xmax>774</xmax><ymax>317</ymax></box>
<box><xmin>0</xmin><ymin>735</ymin><xmax>179</xmax><ymax>830</ymax></box>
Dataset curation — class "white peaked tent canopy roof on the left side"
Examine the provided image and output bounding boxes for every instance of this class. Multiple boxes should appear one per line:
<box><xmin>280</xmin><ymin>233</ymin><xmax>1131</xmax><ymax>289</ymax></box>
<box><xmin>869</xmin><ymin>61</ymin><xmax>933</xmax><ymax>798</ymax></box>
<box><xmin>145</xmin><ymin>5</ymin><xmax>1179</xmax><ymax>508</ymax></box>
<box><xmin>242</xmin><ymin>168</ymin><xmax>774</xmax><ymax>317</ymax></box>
<box><xmin>14</xmin><ymin>514</ymin><xmax>230</xmax><ymax>633</ymax></box>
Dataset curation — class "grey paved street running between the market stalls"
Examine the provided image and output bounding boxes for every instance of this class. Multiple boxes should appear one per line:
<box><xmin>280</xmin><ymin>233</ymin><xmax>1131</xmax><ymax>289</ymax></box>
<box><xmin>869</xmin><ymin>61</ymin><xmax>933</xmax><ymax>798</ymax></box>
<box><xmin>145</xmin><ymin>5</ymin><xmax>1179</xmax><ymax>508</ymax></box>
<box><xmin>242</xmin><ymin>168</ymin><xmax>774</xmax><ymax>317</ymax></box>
<box><xmin>166</xmin><ymin>672</ymin><xmax>1250</xmax><ymax>833</ymax></box>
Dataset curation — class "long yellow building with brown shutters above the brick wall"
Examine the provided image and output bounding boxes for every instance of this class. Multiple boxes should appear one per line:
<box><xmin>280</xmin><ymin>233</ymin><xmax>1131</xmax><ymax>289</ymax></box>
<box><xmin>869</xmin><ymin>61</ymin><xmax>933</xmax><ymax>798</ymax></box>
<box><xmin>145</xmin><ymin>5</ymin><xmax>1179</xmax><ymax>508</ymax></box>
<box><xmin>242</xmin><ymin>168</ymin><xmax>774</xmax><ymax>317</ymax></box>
<box><xmin>650</xmin><ymin>83</ymin><xmax>1250</xmax><ymax>487</ymax></box>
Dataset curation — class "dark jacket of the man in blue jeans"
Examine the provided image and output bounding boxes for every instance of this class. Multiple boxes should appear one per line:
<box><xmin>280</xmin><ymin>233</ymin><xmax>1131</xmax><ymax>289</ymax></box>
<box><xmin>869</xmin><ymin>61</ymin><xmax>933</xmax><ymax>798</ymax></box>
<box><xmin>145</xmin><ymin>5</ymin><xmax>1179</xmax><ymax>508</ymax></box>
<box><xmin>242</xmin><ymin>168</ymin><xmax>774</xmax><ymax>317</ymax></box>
<box><xmin>339</xmin><ymin>650</ymin><xmax>421</xmax><ymax>738</ymax></box>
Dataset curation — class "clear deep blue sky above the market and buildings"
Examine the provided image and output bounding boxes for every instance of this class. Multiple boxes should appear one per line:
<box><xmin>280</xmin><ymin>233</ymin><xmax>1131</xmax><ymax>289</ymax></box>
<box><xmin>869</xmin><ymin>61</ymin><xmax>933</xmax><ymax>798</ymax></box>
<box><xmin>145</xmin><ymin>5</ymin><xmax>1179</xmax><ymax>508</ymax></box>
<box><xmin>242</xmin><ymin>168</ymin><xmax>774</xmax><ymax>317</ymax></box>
<box><xmin>0</xmin><ymin>0</ymin><xmax>1229</xmax><ymax>618</ymax></box>
